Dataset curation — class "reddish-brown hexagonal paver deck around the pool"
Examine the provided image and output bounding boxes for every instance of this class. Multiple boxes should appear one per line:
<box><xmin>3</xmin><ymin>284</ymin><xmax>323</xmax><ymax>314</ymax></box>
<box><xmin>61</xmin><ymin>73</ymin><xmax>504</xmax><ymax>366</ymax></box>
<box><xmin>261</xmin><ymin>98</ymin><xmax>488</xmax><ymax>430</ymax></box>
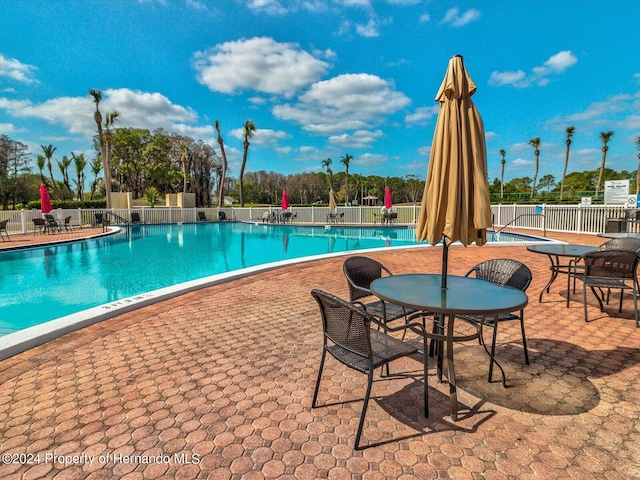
<box><xmin>0</xmin><ymin>230</ymin><xmax>640</xmax><ymax>480</ymax></box>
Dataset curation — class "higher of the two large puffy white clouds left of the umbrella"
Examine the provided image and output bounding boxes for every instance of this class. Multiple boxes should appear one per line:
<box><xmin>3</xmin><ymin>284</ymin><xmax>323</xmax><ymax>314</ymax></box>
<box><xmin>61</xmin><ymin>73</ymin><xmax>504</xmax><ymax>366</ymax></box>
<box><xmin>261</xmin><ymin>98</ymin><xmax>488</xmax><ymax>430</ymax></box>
<box><xmin>194</xmin><ymin>37</ymin><xmax>328</xmax><ymax>96</ymax></box>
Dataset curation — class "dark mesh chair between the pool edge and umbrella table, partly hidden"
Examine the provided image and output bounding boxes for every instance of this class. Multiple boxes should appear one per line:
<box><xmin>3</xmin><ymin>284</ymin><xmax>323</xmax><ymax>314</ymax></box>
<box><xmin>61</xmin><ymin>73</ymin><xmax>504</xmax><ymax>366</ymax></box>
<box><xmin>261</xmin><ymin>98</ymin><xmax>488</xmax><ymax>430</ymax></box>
<box><xmin>342</xmin><ymin>256</ymin><xmax>416</xmax><ymax>323</ymax></box>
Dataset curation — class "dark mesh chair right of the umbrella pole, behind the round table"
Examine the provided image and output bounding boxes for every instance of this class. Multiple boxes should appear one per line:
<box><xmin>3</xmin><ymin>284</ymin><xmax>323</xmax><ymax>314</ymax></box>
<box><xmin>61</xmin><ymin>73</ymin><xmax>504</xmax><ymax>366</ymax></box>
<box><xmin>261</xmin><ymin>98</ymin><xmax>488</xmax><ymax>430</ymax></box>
<box><xmin>464</xmin><ymin>258</ymin><xmax>532</xmax><ymax>385</ymax></box>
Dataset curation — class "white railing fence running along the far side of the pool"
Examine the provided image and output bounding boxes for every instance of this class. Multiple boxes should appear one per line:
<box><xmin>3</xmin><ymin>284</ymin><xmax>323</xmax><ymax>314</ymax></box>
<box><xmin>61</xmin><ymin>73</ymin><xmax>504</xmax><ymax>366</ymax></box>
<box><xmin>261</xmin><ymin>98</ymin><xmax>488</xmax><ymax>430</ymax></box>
<box><xmin>0</xmin><ymin>204</ymin><xmax>635</xmax><ymax>234</ymax></box>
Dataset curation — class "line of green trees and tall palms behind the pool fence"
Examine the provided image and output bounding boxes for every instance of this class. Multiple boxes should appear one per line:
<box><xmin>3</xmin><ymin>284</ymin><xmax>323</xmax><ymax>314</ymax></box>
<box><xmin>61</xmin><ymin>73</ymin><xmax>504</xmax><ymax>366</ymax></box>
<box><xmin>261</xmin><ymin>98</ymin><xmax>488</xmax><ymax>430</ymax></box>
<box><xmin>0</xmin><ymin>93</ymin><xmax>640</xmax><ymax>209</ymax></box>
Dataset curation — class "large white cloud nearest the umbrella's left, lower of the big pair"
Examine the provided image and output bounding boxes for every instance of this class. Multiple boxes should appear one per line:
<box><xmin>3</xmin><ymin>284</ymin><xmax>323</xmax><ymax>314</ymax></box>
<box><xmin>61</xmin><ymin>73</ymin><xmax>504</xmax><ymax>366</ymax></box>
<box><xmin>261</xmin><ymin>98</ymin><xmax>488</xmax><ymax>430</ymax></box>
<box><xmin>273</xmin><ymin>73</ymin><xmax>411</xmax><ymax>134</ymax></box>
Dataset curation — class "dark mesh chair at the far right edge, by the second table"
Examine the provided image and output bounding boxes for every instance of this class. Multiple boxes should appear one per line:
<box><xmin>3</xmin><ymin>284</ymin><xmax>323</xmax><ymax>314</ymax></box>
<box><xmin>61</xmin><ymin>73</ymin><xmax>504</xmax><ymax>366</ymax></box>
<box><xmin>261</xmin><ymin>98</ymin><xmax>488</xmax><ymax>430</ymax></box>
<box><xmin>575</xmin><ymin>249</ymin><xmax>640</xmax><ymax>328</ymax></box>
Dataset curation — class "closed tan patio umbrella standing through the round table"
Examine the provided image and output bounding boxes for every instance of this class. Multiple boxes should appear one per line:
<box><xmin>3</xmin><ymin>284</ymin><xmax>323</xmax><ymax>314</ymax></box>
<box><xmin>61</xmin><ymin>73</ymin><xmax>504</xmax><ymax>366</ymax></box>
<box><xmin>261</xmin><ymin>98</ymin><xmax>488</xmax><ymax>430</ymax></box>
<box><xmin>416</xmin><ymin>55</ymin><xmax>491</xmax><ymax>288</ymax></box>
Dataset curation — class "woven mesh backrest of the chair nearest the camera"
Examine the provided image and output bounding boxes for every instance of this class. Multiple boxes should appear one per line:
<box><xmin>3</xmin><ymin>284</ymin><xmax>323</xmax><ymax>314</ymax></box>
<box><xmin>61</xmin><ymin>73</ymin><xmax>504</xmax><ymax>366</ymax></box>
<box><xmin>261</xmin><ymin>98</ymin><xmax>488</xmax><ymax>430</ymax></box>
<box><xmin>311</xmin><ymin>290</ymin><xmax>371</xmax><ymax>359</ymax></box>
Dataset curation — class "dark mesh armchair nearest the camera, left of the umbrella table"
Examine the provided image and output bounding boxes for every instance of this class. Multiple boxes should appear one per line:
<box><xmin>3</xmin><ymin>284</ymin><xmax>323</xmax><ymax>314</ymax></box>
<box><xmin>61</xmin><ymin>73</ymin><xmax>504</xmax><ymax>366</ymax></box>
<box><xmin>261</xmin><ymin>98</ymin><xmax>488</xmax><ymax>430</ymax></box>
<box><xmin>311</xmin><ymin>290</ymin><xmax>429</xmax><ymax>450</ymax></box>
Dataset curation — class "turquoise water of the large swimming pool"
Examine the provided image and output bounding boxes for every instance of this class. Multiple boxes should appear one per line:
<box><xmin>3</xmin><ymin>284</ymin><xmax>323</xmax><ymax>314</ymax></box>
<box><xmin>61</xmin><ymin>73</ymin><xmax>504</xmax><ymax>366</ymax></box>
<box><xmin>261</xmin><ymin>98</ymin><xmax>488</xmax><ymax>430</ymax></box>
<box><xmin>0</xmin><ymin>223</ymin><xmax>544</xmax><ymax>335</ymax></box>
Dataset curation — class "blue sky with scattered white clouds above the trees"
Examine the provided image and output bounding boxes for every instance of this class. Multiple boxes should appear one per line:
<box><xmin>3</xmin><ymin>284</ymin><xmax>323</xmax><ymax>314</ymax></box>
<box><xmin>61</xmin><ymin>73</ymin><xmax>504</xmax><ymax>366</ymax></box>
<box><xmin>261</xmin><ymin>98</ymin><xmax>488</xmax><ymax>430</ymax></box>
<box><xmin>0</xmin><ymin>0</ymin><xmax>640</xmax><ymax>186</ymax></box>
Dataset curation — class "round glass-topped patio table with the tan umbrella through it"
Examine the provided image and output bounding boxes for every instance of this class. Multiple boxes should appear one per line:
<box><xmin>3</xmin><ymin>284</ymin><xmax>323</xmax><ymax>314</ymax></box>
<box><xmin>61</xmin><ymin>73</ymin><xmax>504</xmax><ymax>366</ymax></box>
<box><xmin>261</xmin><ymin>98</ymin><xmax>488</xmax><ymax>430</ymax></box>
<box><xmin>371</xmin><ymin>274</ymin><xmax>529</xmax><ymax>420</ymax></box>
